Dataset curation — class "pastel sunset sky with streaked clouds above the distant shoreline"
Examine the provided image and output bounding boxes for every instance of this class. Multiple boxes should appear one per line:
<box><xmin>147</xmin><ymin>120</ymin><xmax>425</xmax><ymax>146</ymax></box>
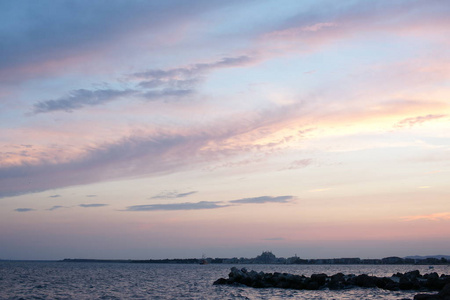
<box><xmin>0</xmin><ymin>0</ymin><xmax>450</xmax><ymax>259</ymax></box>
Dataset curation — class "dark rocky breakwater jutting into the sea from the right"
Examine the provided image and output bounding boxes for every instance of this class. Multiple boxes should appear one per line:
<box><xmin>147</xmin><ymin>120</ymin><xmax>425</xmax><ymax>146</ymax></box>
<box><xmin>214</xmin><ymin>267</ymin><xmax>450</xmax><ymax>300</ymax></box>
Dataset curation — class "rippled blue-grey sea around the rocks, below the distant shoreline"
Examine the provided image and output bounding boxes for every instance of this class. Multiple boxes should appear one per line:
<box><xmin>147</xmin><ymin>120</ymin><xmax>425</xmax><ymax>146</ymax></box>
<box><xmin>0</xmin><ymin>261</ymin><xmax>450</xmax><ymax>300</ymax></box>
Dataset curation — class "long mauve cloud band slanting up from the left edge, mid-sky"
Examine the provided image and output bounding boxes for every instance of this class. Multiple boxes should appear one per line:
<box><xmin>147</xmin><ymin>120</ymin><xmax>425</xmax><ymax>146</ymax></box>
<box><xmin>0</xmin><ymin>102</ymin><xmax>310</xmax><ymax>197</ymax></box>
